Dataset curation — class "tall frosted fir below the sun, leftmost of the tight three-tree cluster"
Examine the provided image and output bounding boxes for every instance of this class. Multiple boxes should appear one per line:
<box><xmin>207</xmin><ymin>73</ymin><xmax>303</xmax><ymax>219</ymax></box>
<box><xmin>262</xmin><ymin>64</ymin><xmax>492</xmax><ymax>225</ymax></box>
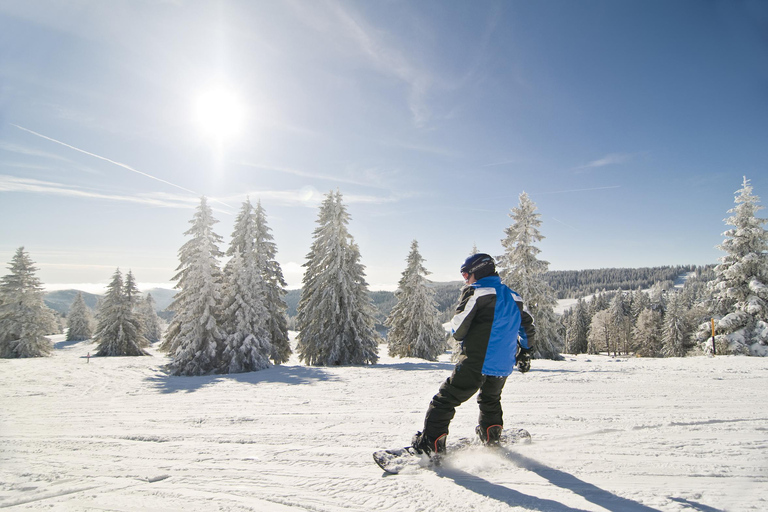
<box><xmin>163</xmin><ymin>197</ymin><xmax>225</xmax><ymax>375</ymax></box>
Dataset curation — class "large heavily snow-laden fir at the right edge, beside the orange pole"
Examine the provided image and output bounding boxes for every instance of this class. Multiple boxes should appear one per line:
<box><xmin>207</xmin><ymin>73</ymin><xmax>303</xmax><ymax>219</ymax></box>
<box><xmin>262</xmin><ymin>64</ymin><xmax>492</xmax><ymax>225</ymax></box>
<box><xmin>698</xmin><ymin>177</ymin><xmax>768</xmax><ymax>356</ymax></box>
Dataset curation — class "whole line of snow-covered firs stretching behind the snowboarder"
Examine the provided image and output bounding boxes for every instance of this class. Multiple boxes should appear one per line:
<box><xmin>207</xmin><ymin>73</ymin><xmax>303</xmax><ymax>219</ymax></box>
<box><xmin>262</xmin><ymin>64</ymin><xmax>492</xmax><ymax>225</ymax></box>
<box><xmin>0</xmin><ymin>177</ymin><xmax>768</xmax><ymax>364</ymax></box>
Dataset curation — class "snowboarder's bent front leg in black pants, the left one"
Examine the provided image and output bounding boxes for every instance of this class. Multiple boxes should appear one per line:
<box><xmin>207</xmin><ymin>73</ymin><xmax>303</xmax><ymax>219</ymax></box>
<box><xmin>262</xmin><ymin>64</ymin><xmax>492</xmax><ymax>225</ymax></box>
<box><xmin>424</xmin><ymin>365</ymin><xmax>483</xmax><ymax>439</ymax></box>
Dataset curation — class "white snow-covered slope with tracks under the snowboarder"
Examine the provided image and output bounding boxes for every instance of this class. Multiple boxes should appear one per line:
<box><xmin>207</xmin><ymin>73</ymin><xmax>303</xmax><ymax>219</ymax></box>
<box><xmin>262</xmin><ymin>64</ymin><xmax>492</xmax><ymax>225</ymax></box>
<box><xmin>0</xmin><ymin>337</ymin><xmax>768</xmax><ymax>512</ymax></box>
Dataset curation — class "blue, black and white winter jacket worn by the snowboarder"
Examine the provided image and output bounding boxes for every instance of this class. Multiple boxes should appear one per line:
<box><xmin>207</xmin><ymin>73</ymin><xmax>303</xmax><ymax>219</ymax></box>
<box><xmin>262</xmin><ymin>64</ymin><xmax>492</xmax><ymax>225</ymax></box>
<box><xmin>451</xmin><ymin>275</ymin><xmax>536</xmax><ymax>377</ymax></box>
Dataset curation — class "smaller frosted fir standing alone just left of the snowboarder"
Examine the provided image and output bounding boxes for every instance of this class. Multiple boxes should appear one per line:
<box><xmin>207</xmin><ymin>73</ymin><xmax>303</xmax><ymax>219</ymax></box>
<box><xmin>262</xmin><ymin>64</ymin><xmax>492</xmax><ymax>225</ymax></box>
<box><xmin>385</xmin><ymin>240</ymin><xmax>446</xmax><ymax>361</ymax></box>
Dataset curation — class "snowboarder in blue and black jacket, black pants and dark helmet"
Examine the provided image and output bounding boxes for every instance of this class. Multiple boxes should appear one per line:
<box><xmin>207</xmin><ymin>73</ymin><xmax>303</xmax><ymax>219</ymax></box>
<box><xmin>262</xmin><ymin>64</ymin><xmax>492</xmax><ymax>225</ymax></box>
<box><xmin>412</xmin><ymin>253</ymin><xmax>536</xmax><ymax>456</ymax></box>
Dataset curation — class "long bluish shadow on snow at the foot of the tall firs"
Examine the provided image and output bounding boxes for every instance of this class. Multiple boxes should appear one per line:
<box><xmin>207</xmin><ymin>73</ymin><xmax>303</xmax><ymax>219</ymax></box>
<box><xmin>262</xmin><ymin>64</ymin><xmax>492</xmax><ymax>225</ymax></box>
<box><xmin>146</xmin><ymin>365</ymin><xmax>338</xmax><ymax>393</ymax></box>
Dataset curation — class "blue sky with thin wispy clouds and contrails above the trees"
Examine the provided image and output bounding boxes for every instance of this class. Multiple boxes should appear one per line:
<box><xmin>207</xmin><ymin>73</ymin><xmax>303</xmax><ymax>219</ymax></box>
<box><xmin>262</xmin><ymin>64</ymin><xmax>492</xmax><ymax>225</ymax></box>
<box><xmin>0</xmin><ymin>0</ymin><xmax>768</xmax><ymax>289</ymax></box>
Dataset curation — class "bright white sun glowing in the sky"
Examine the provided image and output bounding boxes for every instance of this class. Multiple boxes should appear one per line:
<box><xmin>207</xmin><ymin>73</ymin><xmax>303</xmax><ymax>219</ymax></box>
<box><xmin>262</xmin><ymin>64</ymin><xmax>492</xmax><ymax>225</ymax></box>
<box><xmin>195</xmin><ymin>87</ymin><xmax>245</xmax><ymax>143</ymax></box>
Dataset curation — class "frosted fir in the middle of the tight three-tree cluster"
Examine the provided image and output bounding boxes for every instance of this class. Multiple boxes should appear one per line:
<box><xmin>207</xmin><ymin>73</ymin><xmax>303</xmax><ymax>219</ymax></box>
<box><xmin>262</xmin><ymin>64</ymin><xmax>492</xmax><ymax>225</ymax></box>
<box><xmin>221</xmin><ymin>200</ymin><xmax>272</xmax><ymax>373</ymax></box>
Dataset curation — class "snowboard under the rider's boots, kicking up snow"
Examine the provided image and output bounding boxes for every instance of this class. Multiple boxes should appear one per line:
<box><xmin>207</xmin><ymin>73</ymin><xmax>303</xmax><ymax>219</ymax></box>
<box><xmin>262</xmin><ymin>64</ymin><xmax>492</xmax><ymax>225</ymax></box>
<box><xmin>373</xmin><ymin>428</ymin><xmax>531</xmax><ymax>475</ymax></box>
